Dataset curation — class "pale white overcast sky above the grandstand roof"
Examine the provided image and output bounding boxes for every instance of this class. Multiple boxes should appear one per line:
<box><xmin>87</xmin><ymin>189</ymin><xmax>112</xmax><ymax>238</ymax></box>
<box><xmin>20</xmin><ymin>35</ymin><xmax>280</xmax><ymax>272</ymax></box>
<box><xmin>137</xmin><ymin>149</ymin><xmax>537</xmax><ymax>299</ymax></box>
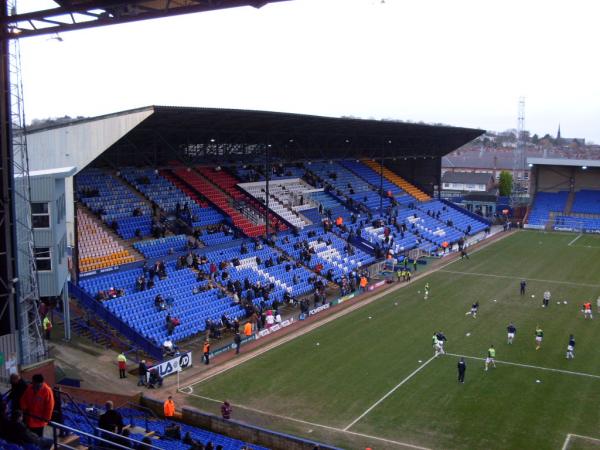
<box><xmin>19</xmin><ymin>0</ymin><xmax>600</xmax><ymax>143</ymax></box>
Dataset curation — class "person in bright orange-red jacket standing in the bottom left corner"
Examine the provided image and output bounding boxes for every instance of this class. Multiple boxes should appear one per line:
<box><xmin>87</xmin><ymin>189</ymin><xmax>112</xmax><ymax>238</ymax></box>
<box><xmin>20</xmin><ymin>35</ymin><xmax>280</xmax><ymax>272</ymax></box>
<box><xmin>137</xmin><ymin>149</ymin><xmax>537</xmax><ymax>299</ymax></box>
<box><xmin>21</xmin><ymin>373</ymin><xmax>54</xmax><ymax>437</ymax></box>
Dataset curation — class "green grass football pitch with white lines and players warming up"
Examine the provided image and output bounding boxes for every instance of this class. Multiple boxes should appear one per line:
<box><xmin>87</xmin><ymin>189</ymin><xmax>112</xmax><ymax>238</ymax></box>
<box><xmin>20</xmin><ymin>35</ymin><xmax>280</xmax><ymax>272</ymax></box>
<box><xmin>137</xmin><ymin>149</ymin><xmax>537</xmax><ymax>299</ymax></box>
<box><xmin>182</xmin><ymin>231</ymin><xmax>600</xmax><ymax>450</ymax></box>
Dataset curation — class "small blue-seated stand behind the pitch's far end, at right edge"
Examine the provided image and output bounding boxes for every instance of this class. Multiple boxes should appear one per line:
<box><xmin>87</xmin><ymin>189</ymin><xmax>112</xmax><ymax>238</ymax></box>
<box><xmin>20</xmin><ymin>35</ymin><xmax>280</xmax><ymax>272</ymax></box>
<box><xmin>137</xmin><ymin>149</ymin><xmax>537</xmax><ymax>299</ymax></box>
<box><xmin>525</xmin><ymin>158</ymin><xmax>600</xmax><ymax>233</ymax></box>
